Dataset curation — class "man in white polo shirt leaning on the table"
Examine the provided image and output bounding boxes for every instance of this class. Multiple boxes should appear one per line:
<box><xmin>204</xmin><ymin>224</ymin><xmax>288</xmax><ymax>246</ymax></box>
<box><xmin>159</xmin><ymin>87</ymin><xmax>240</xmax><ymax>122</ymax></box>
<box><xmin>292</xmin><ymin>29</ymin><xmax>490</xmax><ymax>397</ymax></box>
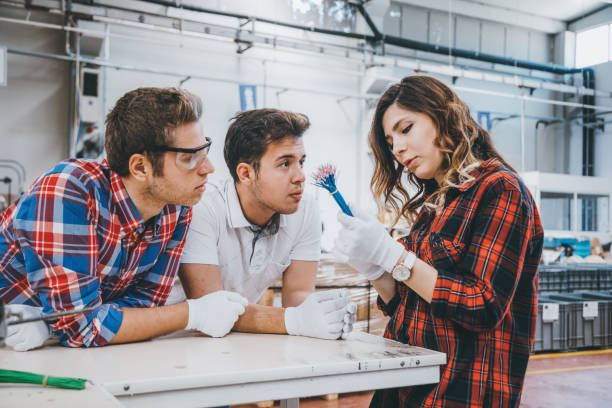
<box><xmin>169</xmin><ymin>109</ymin><xmax>356</xmax><ymax>339</ymax></box>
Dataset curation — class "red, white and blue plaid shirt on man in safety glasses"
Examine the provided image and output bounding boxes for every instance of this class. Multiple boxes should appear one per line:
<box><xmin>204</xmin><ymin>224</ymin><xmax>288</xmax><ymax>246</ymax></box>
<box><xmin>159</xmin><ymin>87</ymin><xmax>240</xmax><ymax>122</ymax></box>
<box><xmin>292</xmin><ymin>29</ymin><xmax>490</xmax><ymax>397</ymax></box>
<box><xmin>0</xmin><ymin>159</ymin><xmax>191</xmax><ymax>347</ymax></box>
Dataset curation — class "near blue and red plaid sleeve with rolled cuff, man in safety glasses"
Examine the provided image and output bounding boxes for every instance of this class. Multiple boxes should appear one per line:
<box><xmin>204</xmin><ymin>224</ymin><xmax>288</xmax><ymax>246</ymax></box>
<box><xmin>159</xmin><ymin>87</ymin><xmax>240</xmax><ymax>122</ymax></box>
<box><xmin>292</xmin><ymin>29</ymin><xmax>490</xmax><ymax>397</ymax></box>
<box><xmin>14</xmin><ymin>173</ymin><xmax>123</xmax><ymax>347</ymax></box>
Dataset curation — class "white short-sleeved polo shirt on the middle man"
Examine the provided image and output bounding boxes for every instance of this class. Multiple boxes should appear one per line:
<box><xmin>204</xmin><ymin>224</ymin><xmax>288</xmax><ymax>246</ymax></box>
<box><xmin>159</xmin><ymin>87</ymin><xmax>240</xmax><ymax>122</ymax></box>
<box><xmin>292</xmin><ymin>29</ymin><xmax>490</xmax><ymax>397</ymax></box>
<box><xmin>166</xmin><ymin>178</ymin><xmax>321</xmax><ymax>304</ymax></box>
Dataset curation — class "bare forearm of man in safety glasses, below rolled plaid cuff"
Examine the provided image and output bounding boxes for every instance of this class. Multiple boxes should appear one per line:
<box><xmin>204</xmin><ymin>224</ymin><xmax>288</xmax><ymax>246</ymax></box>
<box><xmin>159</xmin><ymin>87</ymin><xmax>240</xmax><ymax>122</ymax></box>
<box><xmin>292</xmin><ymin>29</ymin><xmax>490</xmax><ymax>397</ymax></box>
<box><xmin>110</xmin><ymin>302</ymin><xmax>189</xmax><ymax>344</ymax></box>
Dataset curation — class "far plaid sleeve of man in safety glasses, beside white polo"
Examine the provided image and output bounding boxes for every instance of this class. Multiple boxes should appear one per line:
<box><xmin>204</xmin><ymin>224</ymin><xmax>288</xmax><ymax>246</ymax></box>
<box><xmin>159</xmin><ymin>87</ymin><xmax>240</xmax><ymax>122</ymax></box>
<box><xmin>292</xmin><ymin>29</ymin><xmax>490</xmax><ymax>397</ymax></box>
<box><xmin>109</xmin><ymin>207</ymin><xmax>191</xmax><ymax>307</ymax></box>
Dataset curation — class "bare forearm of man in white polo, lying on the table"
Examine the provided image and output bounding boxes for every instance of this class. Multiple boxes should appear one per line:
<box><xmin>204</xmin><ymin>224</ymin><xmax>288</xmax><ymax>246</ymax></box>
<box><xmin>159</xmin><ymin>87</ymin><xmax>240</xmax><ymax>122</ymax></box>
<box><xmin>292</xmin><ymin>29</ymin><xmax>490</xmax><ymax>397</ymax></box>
<box><xmin>232</xmin><ymin>303</ymin><xmax>287</xmax><ymax>334</ymax></box>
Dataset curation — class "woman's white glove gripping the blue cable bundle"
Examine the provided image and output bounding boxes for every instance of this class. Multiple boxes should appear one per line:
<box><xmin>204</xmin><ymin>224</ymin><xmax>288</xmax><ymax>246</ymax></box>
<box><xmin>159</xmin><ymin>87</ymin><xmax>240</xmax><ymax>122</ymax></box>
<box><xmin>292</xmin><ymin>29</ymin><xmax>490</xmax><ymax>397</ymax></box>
<box><xmin>335</xmin><ymin>207</ymin><xmax>405</xmax><ymax>274</ymax></box>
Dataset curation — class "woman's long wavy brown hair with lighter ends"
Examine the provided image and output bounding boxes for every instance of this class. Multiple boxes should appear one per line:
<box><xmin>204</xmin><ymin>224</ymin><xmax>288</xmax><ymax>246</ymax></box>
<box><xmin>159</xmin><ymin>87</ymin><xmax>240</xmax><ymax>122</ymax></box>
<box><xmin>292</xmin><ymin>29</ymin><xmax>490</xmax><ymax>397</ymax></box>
<box><xmin>368</xmin><ymin>76</ymin><xmax>514</xmax><ymax>224</ymax></box>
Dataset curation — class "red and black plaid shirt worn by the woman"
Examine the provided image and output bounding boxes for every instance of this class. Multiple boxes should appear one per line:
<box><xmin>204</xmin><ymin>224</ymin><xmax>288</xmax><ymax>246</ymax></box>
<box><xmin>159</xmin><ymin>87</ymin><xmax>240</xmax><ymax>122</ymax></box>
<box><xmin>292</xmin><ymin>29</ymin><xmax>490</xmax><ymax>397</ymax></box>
<box><xmin>371</xmin><ymin>159</ymin><xmax>543</xmax><ymax>407</ymax></box>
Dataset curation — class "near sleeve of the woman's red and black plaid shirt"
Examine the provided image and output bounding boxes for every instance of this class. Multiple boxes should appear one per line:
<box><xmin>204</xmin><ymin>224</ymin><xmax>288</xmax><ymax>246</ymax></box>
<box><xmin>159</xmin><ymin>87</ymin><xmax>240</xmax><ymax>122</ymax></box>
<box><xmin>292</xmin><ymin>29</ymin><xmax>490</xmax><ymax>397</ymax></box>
<box><xmin>430</xmin><ymin>178</ymin><xmax>533</xmax><ymax>331</ymax></box>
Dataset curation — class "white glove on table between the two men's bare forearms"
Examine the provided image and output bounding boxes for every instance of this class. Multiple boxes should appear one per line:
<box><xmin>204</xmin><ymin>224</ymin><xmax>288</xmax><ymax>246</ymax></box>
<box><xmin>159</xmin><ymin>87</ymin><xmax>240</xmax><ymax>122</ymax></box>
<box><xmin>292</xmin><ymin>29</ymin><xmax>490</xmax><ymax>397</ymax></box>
<box><xmin>186</xmin><ymin>290</ymin><xmax>249</xmax><ymax>337</ymax></box>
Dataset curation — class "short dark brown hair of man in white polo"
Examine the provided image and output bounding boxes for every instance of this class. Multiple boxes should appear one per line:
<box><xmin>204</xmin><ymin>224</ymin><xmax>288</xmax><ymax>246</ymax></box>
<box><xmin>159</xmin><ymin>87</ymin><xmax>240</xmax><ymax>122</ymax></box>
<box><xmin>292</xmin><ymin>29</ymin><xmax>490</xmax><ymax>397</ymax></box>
<box><xmin>223</xmin><ymin>109</ymin><xmax>310</xmax><ymax>182</ymax></box>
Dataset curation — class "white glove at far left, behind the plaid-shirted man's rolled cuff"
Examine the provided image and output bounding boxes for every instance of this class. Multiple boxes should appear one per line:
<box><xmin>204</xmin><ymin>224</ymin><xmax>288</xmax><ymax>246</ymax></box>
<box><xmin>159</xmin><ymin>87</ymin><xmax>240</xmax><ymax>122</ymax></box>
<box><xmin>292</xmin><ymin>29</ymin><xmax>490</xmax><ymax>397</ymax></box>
<box><xmin>4</xmin><ymin>304</ymin><xmax>51</xmax><ymax>351</ymax></box>
